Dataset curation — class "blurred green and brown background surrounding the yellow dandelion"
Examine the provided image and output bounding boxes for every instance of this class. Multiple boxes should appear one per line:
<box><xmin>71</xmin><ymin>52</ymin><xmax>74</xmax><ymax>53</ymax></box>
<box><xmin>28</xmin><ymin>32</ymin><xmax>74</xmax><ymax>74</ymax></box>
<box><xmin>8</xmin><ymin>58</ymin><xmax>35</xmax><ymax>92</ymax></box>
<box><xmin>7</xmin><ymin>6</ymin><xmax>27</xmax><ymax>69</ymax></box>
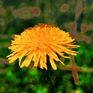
<box><xmin>0</xmin><ymin>0</ymin><xmax>93</xmax><ymax>93</ymax></box>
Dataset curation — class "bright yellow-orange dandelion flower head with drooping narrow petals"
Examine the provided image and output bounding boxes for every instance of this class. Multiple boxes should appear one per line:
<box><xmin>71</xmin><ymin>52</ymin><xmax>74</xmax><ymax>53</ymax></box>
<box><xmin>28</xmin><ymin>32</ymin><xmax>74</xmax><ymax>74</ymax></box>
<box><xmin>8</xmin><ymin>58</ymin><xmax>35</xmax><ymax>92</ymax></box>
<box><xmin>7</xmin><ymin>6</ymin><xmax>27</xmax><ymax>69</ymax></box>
<box><xmin>7</xmin><ymin>24</ymin><xmax>78</xmax><ymax>70</ymax></box>
